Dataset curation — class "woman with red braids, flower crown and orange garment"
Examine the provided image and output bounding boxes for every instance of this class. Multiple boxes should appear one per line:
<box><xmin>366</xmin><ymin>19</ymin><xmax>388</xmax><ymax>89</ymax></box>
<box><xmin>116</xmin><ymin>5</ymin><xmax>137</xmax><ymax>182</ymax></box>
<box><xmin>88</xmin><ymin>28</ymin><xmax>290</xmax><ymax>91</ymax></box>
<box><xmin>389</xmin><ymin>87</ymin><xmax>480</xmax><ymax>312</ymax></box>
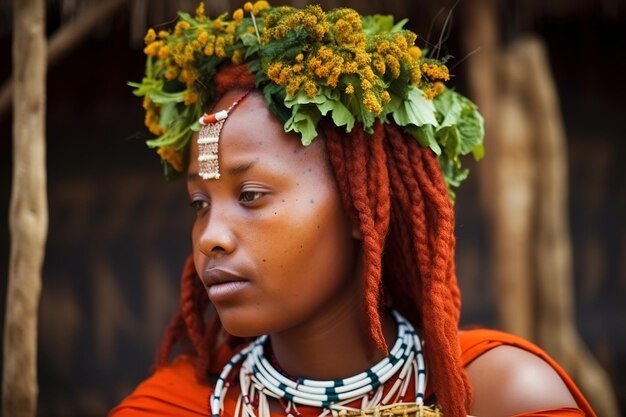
<box><xmin>111</xmin><ymin>1</ymin><xmax>594</xmax><ymax>417</ymax></box>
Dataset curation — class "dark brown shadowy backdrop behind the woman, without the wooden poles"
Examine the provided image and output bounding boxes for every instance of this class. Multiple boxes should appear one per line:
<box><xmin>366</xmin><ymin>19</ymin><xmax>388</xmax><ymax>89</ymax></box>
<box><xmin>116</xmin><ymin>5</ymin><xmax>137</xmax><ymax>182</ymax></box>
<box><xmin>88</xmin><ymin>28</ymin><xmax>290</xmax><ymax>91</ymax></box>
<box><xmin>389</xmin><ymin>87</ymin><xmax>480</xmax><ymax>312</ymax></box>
<box><xmin>0</xmin><ymin>0</ymin><xmax>626</xmax><ymax>416</ymax></box>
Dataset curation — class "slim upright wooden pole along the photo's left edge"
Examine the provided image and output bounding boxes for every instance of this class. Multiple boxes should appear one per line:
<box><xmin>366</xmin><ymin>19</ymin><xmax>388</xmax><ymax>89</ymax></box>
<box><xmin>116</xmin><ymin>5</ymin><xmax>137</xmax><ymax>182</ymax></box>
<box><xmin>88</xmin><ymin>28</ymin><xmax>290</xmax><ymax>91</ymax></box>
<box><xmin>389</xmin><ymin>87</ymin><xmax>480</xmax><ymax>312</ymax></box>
<box><xmin>2</xmin><ymin>0</ymin><xmax>48</xmax><ymax>417</ymax></box>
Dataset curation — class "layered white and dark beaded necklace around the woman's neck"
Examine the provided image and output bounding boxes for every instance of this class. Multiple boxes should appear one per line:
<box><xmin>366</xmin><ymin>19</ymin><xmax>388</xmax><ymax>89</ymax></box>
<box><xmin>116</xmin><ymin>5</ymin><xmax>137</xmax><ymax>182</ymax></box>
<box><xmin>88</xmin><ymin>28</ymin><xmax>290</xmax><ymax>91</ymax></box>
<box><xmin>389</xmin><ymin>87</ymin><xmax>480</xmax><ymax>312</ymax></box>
<box><xmin>209</xmin><ymin>310</ymin><xmax>426</xmax><ymax>417</ymax></box>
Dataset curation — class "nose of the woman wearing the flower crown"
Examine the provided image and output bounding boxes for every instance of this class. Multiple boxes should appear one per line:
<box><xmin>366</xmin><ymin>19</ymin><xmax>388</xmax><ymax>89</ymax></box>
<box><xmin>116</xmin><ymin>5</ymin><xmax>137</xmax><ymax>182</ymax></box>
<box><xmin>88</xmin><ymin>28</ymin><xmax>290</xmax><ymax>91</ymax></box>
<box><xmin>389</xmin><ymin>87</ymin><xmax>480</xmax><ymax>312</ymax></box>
<box><xmin>193</xmin><ymin>206</ymin><xmax>237</xmax><ymax>256</ymax></box>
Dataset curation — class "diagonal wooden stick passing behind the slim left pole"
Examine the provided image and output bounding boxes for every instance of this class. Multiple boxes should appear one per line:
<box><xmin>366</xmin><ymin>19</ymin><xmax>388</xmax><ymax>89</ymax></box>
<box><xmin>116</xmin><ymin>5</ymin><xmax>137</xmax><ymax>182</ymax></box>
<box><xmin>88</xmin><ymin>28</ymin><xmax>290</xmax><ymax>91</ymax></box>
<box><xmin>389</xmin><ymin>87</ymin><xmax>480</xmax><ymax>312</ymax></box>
<box><xmin>0</xmin><ymin>0</ymin><xmax>129</xmax><ymax>116</ymax></box>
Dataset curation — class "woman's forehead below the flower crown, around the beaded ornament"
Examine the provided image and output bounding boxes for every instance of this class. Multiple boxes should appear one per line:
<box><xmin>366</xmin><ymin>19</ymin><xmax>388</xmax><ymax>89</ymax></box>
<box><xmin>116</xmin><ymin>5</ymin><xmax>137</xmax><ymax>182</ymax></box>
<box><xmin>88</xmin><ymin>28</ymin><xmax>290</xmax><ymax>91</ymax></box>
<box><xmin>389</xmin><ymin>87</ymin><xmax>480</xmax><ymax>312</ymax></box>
<box><xmin>190</xmin><ymin>90</ymin><xmax>326</xmax><ymax>171</ymax></box>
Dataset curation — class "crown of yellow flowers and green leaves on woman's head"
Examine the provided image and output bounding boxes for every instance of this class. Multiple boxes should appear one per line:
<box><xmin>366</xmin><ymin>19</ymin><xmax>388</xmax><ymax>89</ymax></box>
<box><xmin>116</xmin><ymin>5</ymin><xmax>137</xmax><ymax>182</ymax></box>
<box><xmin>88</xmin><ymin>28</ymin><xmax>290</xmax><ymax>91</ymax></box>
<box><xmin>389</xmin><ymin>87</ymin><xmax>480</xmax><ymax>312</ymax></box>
<box><xmin>129</xmin><ymin>0</ymin><xmax>484</xmax><ymax>195</ymax></box>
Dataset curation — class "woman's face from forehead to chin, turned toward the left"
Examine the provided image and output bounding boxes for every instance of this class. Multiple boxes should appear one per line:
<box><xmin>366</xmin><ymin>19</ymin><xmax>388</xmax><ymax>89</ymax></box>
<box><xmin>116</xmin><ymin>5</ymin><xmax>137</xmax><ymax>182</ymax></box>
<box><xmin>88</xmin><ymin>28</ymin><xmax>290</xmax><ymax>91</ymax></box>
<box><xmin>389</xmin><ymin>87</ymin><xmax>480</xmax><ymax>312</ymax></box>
<box><xmin>187</xmin><ymin>91</ymin><xmax>361</xmax><ymax>336</ymax></box>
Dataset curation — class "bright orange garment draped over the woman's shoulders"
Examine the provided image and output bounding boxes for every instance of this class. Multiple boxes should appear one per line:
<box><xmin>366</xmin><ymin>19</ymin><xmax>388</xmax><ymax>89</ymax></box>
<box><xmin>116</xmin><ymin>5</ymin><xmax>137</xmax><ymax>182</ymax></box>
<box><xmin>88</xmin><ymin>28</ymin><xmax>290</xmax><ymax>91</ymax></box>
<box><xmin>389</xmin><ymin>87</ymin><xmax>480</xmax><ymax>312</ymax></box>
<box><xmin>109</xmin><ymin>329</ymin><xmax>595</xmax><ymax>417</ymax></box>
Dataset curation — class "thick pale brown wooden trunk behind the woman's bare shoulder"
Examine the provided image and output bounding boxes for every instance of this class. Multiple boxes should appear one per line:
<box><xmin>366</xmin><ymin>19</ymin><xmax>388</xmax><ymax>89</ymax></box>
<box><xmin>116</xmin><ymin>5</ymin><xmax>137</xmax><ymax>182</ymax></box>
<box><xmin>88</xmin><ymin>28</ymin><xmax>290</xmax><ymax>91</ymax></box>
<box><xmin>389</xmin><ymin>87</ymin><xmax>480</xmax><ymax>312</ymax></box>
<box><xmin>464</xmin><ymin>0</ymin><xmax>619</xmax><ymax>417</ymax></box>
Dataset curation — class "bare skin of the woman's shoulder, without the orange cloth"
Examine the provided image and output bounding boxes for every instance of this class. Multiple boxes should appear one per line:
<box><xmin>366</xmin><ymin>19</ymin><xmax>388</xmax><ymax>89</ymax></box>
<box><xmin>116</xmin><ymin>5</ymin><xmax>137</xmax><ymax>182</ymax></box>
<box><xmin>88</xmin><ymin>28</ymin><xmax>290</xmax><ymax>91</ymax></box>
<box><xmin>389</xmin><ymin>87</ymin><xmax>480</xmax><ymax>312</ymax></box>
<box><xmin>467</xmin><ymin>346</ymin><xmax>577</xmax><ymax>417</ymax></box>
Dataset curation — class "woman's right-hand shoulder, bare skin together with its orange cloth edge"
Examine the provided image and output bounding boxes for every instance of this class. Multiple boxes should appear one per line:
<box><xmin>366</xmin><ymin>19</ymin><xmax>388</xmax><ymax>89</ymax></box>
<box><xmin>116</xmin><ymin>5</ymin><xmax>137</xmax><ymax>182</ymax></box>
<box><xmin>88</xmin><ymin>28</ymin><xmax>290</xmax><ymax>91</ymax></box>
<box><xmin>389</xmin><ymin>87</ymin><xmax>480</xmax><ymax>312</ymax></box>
<box><xmin>460</xmin><ymin>330</ymin><xmax>584</xmax><ymax>416</ymax></box>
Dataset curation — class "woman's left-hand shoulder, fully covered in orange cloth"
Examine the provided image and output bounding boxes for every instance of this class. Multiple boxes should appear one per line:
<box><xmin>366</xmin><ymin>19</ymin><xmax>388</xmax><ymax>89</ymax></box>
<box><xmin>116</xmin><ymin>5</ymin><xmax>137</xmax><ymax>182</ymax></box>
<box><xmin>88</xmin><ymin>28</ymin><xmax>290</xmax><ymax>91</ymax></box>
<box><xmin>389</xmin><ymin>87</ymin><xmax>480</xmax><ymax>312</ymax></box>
<box><xmin>109</xmin><ymin>356</ymin><xmax>211</xmax><ymax>417</ymax></box>
